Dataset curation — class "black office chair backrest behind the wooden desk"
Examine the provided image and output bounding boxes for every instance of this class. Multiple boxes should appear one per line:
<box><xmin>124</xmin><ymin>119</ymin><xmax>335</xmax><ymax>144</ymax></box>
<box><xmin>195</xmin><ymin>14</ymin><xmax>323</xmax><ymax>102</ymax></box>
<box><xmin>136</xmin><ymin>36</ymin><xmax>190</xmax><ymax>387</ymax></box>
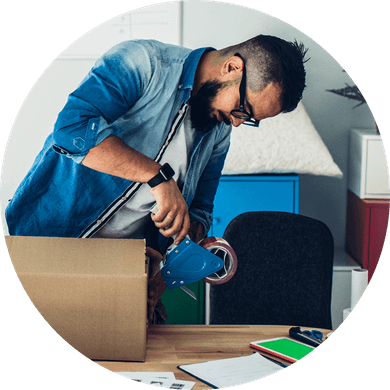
<box><xmin>210</xmin><ymin>211</ymin><xmax>334</xmax><ymax>329</ymax></box>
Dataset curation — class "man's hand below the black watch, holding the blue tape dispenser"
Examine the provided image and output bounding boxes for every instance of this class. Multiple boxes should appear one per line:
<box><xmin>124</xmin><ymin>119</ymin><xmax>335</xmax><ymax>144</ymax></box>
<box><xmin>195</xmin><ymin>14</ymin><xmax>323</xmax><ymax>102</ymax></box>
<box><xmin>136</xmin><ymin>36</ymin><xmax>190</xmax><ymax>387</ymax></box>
<box><xmin>150</xmin><ymin>179</ymin><xmax>190</xmax><ymax>245</ymax></box>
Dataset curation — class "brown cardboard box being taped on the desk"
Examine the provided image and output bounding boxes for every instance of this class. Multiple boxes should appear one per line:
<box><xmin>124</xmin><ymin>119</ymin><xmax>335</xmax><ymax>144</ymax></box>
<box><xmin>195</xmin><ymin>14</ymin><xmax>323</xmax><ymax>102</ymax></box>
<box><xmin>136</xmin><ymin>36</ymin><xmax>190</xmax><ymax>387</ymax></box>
<box><xmin>5</xmin><ymin>236</ymin><xmax>149</xmax><ymax>361</ymax></box>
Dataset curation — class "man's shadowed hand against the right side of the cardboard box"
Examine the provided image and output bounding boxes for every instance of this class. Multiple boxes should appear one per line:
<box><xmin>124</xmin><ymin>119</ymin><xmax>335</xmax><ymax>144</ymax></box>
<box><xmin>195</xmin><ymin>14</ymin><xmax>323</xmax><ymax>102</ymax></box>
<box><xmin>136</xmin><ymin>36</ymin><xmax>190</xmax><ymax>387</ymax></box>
<box><xmin>146</xmin><ymin>247</ymin><xmax>167</xmax><ymax>322</ymax></box>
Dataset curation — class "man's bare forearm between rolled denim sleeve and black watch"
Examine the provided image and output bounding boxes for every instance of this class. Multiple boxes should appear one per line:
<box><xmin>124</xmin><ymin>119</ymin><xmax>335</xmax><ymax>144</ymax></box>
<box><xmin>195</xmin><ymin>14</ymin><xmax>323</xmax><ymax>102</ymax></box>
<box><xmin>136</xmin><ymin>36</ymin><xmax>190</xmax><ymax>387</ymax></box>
<box><xmin>82</xmin><ymin>136</ymin><xmax>161</xmax><ymax>183</ymax></box>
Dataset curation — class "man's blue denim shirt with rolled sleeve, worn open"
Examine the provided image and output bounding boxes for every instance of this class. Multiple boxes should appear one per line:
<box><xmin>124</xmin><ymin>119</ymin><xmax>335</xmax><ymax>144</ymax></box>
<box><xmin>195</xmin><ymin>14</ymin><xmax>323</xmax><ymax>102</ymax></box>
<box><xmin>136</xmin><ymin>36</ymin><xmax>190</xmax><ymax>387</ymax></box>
<box><xmin>5</xmin><ymin>40</ymin><xmax>231</xmax><ymax>238</ymax></box>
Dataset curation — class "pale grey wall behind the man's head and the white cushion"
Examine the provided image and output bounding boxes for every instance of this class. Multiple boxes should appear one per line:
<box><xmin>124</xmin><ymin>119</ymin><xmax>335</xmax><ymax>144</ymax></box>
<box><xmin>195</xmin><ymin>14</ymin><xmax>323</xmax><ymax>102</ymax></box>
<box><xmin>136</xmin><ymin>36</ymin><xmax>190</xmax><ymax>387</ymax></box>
<box><xmin>183</xmin><ymin>1</ymin><xmax>375</xmax><ymax>247</ymax></box>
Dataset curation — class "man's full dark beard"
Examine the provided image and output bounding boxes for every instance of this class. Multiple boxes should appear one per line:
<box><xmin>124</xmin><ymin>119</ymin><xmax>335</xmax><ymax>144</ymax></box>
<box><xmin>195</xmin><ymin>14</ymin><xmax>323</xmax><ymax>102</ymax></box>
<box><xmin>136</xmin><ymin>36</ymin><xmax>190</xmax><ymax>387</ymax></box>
<box><xmin>189</xmin><ymin>80</ymin><xmax>230</xmax><ymax>132</ymax></box>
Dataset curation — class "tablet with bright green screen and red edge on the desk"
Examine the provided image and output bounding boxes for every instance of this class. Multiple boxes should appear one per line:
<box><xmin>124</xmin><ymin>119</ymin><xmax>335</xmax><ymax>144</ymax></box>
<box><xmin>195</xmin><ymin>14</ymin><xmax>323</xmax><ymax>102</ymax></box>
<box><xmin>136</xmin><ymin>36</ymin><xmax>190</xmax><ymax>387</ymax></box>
<box><xmin>250</xmin><ymin>337</ymin><xmax>315</xmax><ymax>363</ymax></box>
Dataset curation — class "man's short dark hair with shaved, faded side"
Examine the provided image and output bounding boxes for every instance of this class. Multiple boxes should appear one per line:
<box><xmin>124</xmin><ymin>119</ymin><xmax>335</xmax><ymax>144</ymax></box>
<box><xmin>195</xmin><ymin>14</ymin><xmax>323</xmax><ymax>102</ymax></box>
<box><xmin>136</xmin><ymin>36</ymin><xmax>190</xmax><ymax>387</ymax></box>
<box><xmin>226</xmin><ymin>35</ymin><xmax>309</xmax><ymax>112</ymax></box>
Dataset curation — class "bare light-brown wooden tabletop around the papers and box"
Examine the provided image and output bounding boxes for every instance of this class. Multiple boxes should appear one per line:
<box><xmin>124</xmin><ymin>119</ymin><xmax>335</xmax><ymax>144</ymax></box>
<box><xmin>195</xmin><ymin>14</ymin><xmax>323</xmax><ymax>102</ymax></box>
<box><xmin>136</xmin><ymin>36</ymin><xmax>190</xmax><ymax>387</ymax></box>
<box><xmin>96</xmin><ymin>325</ymin><xmax>331</xmax><ymax>390</ymax></box>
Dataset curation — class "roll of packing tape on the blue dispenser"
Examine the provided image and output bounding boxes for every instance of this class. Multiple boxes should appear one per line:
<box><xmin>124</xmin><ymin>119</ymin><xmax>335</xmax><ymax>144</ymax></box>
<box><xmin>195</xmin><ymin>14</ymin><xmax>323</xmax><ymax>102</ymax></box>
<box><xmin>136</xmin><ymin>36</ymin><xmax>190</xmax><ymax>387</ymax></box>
<box><xmin>199</xmin><ymin>237</ymin><xmax>237</xmax><ymax>284</ymax></box>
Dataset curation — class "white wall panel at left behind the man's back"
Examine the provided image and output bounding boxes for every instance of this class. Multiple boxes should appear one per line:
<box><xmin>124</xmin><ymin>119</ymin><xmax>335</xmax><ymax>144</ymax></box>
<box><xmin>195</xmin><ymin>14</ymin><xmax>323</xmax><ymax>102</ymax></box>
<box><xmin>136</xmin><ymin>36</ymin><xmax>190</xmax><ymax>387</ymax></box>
<box><xmin>1</xmin><ymin>2</ymin><xmax>181</xmax><ymax>234</ymax></box>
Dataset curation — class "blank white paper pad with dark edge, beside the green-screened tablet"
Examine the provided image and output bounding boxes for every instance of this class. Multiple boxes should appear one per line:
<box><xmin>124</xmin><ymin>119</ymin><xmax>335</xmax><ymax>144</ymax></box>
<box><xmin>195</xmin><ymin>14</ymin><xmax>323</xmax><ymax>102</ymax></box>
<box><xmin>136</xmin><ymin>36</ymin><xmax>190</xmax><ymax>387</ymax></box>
<box><xmin>179</xmin><ymin>353</ymin><xmax>283</xmax><ymax>389</ymax></box>
